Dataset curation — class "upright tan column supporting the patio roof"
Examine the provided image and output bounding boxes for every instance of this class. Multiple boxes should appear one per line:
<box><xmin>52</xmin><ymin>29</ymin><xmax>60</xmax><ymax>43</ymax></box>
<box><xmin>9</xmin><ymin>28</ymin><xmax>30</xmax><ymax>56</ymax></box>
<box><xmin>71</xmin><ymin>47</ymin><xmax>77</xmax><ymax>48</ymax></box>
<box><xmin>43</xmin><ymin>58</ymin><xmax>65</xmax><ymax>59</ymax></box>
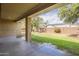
<box><xmin>25</xmin><ymin>17</ymin><xmax>31</xmax><ymax>42</ymax></box>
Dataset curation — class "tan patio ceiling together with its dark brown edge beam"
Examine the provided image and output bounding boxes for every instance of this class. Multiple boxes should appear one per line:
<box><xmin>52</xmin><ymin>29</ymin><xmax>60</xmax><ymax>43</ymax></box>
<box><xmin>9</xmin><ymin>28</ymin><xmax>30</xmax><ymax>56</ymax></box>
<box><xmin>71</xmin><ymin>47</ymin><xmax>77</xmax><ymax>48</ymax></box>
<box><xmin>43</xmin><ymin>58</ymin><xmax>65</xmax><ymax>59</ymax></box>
<box><xmin>0</xmin><ymin>3</ymin><xmax>53</xmax><ymax>21</ymax></box>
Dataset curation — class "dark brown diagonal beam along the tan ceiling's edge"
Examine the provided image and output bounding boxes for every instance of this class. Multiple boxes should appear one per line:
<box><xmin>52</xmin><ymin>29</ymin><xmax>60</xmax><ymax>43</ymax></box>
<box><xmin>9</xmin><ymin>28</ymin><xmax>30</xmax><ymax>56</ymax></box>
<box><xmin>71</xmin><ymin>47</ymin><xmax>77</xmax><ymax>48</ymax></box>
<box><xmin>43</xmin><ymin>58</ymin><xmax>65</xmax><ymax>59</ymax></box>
<box><xmin>15</xmin><ymin>3</ymin><xmax>55</xmax><ymax>21</ymax></box>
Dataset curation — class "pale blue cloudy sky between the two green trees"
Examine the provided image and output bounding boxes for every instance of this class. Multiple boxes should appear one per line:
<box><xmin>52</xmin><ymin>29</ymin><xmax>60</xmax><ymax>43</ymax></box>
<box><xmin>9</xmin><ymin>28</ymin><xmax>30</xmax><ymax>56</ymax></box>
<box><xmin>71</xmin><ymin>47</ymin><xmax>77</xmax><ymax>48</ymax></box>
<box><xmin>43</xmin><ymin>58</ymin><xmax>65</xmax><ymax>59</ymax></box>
<box><xmin>39</xmin><ymin>9</ymin><xmax>63</xmax><ymax>24</ymax></box>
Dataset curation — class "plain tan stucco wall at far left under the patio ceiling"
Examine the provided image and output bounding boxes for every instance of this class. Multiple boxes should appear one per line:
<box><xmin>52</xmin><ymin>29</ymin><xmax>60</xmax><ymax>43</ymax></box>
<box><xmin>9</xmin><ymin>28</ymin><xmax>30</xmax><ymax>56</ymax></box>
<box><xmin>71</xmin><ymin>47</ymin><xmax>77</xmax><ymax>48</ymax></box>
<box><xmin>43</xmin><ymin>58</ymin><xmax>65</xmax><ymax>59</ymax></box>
<box><xmin>0</xmin><ymin>21</ymin><xmax>17</xmax><ymax>36</ymax></box>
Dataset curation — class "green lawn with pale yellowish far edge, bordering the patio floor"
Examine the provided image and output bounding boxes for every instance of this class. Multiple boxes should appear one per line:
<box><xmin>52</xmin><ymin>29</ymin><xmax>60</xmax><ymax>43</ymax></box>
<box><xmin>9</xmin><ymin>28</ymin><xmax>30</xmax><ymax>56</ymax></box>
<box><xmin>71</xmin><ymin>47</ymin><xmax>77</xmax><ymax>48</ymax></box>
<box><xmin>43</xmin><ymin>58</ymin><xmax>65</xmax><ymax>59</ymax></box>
<box><xmin>32</xmin><ymin>33</ymin><xmax>79</xmax><ymax>55</ymax></box>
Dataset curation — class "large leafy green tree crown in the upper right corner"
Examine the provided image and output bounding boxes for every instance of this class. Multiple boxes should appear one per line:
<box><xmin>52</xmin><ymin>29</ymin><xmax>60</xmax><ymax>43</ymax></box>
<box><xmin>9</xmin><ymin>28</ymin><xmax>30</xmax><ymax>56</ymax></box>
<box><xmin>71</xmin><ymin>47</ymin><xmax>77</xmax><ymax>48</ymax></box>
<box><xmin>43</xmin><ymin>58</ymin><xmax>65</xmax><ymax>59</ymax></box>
<box><xmin>58</xmin><ymin>4</ymin><xmax>79</xmax><ymax>24</ymax></box>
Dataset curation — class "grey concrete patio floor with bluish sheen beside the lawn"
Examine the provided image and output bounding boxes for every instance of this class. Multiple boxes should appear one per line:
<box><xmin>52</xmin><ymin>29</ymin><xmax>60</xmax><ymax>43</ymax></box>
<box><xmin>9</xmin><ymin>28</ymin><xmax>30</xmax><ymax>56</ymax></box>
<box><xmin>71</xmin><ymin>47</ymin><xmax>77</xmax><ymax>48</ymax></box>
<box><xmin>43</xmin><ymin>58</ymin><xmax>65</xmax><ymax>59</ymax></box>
<box><xmin>0</xmin><ymin>36</ymin><xmax>71</xmax><ymax>56</ymax></box>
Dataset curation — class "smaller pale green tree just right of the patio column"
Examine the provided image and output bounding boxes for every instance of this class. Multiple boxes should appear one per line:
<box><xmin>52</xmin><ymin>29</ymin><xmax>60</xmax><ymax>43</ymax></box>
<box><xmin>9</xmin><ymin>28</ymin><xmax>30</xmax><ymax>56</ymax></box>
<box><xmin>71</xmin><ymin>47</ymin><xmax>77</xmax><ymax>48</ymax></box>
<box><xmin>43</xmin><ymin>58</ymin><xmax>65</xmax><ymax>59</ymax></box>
<box><xmin>32</xmin><ymin>17</ymin><xmax>43</xmax><ymax>32</ymax></box>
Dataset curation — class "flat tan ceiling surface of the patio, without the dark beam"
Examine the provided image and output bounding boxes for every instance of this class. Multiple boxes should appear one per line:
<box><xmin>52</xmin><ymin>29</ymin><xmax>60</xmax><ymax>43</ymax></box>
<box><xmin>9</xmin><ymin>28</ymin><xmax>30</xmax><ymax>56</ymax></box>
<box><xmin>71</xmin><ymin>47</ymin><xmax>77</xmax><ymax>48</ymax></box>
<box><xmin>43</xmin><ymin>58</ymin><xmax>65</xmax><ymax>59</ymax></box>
<box><xmin>1</xmin><ymin>3</ymin><xmax>38</xmax><ymax>20</ymax></box>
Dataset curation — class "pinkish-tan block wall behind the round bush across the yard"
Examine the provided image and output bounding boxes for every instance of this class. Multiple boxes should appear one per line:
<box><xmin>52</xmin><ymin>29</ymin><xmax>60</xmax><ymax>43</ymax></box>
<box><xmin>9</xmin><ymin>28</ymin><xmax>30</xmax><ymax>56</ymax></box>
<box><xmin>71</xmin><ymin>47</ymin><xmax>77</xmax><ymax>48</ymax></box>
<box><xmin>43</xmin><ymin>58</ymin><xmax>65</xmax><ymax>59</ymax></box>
<box><xmin>46</xmin><ymin>27</ymin><xmax>79</xmax><ymax>34</ymax></box>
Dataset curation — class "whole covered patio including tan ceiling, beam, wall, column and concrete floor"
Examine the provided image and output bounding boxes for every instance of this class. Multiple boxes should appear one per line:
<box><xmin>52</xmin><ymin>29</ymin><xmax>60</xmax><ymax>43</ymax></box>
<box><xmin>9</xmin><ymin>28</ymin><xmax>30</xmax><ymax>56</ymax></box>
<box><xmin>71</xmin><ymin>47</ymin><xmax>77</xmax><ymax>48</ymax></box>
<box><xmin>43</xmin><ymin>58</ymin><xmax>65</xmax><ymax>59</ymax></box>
<box><xmin>0</xmin><ymin>3</ymin><xmax>70</xmax><ymax>56</ymax></box>
